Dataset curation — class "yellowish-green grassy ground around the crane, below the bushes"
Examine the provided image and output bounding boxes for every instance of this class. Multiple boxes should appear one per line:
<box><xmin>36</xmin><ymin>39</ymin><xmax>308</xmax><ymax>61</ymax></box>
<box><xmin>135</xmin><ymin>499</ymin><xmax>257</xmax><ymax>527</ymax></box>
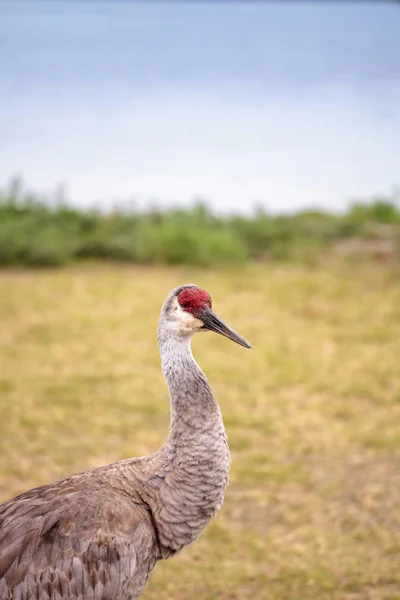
<box><xmin>0</xmin><ymin>263</ymin><xmax>400</xmax><ymax>600</ymax></box>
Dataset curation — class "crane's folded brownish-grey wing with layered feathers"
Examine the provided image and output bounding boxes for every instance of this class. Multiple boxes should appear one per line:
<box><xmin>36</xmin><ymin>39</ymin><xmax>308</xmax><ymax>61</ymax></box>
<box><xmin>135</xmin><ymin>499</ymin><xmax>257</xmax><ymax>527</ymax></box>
<box><xmin>0</xmin><ymin>476</ymin><xmax>157</xmax><ymax>600</ymax></box>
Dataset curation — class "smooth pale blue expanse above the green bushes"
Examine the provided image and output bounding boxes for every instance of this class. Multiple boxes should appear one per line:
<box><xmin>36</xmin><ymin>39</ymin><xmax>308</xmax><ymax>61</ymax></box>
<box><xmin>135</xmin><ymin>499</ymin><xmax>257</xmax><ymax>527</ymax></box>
<box><xmin>0</xmin><ymin>0</ymin><xmax>400</xmax><ymax>211</ymax></box>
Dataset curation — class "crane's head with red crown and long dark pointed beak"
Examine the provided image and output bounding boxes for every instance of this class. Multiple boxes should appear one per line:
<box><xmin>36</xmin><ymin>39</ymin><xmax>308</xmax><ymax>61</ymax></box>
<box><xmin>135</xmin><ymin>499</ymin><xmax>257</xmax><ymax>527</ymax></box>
<box><xmin>160</xmin><ymin>284</ymin><xmax>251</xmax><ymax>348</ymax></box>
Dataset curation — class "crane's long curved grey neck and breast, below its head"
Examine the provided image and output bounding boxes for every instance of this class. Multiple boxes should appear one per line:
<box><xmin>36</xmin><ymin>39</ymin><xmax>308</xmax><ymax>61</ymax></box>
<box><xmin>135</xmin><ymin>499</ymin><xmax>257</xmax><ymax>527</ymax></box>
<box><xmin>128</xmin><ymin>324</ymin><xmax>230</xmax><ymax>558</ymax></box>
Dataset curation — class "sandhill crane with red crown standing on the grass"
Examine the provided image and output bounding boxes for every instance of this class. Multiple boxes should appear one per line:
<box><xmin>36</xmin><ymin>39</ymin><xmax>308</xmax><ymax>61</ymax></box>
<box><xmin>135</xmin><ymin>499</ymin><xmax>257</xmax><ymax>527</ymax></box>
<box><xmin>0</xmin><ymin>284</ymin><xmax>250</xmax><ymax>600</ymax></box>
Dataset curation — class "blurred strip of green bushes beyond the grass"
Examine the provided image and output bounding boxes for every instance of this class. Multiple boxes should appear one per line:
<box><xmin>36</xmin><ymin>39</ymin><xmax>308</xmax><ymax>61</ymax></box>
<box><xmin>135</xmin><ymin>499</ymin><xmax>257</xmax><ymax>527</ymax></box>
<box><xmin>0</xmin><ymin>180</ymin><xmax>400</xmax><ymax>267</ymax></box>
